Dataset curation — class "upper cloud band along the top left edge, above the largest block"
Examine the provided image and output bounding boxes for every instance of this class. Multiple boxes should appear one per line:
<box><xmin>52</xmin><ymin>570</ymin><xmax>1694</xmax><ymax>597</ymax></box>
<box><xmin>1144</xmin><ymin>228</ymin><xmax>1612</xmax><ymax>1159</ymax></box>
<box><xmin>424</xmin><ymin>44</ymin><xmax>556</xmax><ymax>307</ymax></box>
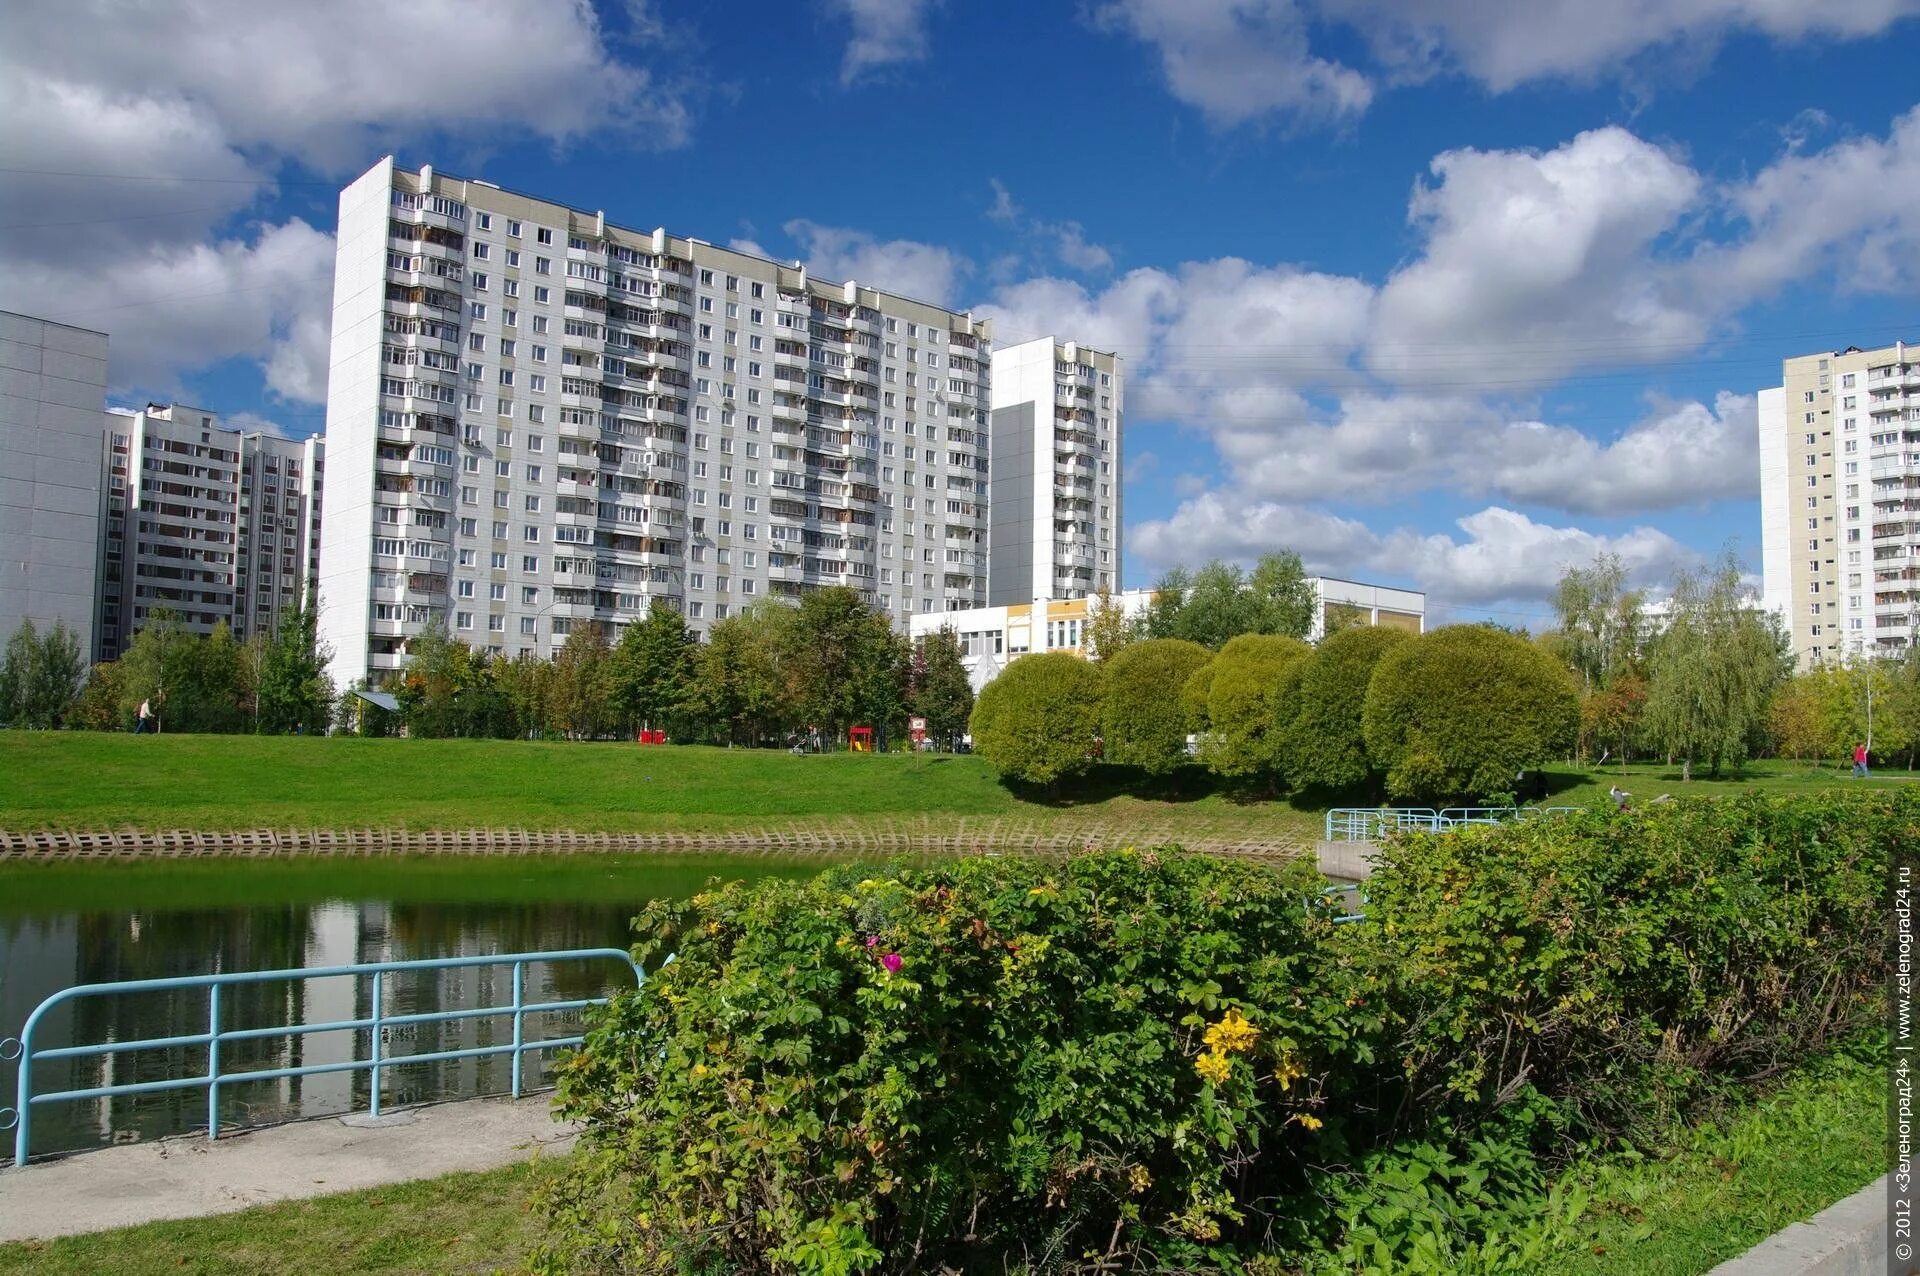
<box><xmin>0</xmin><ymin>0</ymin><xmax>687</xmax><ymax>171</ymax></box>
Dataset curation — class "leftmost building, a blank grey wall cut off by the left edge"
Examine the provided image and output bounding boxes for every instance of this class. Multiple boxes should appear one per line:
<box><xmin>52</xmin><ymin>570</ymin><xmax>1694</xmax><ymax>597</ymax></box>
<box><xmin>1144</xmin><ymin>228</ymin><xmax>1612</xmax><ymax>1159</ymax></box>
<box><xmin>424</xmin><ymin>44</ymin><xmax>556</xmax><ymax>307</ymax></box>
<box><xmin>0</xmin><ymin>311</ymin><xmax>108</xmax><ymax>656</ymax></box>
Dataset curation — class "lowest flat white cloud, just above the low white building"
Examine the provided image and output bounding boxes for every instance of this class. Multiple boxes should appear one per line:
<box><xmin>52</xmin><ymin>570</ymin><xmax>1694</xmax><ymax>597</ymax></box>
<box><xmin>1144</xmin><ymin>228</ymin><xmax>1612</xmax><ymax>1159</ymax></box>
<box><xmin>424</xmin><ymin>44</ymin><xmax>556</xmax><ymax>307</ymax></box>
<box><xmin>1127</xmin><ymin>493</ymin><xmax>1697</xmax><ymax>608</ymax></box>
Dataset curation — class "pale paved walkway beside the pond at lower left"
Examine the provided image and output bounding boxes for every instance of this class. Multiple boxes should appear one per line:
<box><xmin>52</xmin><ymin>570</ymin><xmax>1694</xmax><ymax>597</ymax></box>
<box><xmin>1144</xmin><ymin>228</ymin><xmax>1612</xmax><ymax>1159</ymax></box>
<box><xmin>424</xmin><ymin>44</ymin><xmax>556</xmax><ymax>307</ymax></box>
<box><xmin>0</xmin><ymin>1094</ymin><xmax>574</xmax><ymax>1241</ymax></box>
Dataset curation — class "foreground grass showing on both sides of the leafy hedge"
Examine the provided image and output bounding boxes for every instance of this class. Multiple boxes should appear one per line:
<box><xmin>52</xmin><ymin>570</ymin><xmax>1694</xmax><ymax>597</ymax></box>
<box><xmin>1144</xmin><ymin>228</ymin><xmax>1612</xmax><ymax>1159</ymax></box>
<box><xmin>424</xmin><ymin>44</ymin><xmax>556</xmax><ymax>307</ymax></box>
<box><xmin>0</xmin><ymin>1061</ymin><xmax>1885</xmax><ymax>1276</ymax></box>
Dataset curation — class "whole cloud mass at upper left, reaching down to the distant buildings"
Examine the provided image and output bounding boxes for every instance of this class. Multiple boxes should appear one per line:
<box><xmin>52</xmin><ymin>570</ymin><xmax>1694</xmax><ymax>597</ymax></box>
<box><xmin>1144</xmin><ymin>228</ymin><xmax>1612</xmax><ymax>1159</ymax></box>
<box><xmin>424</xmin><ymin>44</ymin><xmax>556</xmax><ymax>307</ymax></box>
<box><xmin>0</xmin><ymin>0</ymin><xmax>689</xmax><ymax>407</ymax></box>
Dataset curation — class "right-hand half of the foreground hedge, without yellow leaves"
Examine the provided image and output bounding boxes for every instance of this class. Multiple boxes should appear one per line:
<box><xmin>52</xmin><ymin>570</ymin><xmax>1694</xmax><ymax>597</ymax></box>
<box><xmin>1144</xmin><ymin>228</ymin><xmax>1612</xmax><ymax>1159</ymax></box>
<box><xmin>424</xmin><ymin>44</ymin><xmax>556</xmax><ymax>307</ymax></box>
<box><xmin>1367</xmin><ymin>792</ymin><xmax>1920</xmax><ymax>1132</ymax></box>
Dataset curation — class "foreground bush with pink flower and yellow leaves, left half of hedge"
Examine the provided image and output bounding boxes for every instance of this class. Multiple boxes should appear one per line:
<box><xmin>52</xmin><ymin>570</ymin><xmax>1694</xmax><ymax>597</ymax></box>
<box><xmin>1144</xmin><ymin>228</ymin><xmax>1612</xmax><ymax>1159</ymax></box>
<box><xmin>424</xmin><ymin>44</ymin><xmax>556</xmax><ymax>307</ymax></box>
<box><xmin>547</xmin><ymin>852</ymin><xmax>1352</xmax><ymax>1272</ymax></box>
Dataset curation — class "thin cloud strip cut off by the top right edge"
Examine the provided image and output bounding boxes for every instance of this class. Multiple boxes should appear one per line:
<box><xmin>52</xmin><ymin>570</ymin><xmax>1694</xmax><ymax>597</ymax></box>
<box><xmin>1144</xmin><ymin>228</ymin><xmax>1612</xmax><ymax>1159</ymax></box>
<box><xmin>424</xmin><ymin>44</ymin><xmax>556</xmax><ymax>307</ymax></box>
<box><xmin>1319</xmin><ymin>0</ymin><xmax>1920</xmax><ymax>92</ymax></box>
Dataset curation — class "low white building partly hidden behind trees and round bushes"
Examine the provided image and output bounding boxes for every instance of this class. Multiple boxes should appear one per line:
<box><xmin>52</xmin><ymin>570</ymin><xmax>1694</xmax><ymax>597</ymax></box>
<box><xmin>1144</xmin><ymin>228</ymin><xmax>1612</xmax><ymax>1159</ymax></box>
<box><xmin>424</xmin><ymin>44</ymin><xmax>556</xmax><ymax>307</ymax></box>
<box><xmin>908</xmin><ymin>576</ymin><xmax>1427</xmax><ymax>691</ymax></box>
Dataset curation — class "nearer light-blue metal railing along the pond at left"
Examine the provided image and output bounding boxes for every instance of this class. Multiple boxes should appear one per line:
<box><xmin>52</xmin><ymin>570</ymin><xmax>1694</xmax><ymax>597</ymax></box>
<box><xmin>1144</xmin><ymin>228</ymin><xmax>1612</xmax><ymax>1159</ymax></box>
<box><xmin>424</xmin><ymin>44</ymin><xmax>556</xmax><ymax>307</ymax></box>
<box><xmin>0</xmin><ymin>948</ymin><xmax>645</xmax><ymax>1167</ymax></box>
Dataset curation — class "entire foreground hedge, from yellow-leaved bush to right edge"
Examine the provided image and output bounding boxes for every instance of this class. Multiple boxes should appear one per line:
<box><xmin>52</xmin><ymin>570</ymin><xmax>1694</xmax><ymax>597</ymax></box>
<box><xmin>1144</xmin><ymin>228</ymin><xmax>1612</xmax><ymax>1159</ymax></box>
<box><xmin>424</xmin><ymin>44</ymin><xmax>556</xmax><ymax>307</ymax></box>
<box><xmin>541</xmin><ymin>792</ymin><xmax>1920</xmax><ymax>1274</ymax></box>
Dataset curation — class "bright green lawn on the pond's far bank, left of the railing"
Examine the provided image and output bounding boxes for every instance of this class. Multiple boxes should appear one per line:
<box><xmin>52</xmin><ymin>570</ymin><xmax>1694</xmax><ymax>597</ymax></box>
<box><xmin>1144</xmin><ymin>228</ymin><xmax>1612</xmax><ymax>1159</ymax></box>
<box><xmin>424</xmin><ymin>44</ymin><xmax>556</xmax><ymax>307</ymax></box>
<box><xmin>0</xmin><ymin>731</ymin><xmax>1319</xmax><ymax>846</ymax></box>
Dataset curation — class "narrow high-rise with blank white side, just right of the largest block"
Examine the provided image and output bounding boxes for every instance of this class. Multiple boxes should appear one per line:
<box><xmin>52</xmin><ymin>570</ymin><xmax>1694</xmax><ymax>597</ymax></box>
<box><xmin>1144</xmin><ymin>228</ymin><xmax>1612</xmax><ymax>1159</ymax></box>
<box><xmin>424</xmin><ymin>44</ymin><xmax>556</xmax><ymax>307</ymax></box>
<box><xmin>987</xmin><ymin>336</ymin><xmax>1123</xmax><ymax>606</ymax></box>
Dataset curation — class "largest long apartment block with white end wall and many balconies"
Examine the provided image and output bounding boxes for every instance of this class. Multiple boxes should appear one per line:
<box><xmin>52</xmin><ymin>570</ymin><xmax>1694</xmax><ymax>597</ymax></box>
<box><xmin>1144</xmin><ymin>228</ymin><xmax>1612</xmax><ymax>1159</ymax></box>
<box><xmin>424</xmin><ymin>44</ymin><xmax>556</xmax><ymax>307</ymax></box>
<box><xmin>321</xmin><ymin>157</ymin><xmax>991</xmax><ymax>685</ymax></box>
